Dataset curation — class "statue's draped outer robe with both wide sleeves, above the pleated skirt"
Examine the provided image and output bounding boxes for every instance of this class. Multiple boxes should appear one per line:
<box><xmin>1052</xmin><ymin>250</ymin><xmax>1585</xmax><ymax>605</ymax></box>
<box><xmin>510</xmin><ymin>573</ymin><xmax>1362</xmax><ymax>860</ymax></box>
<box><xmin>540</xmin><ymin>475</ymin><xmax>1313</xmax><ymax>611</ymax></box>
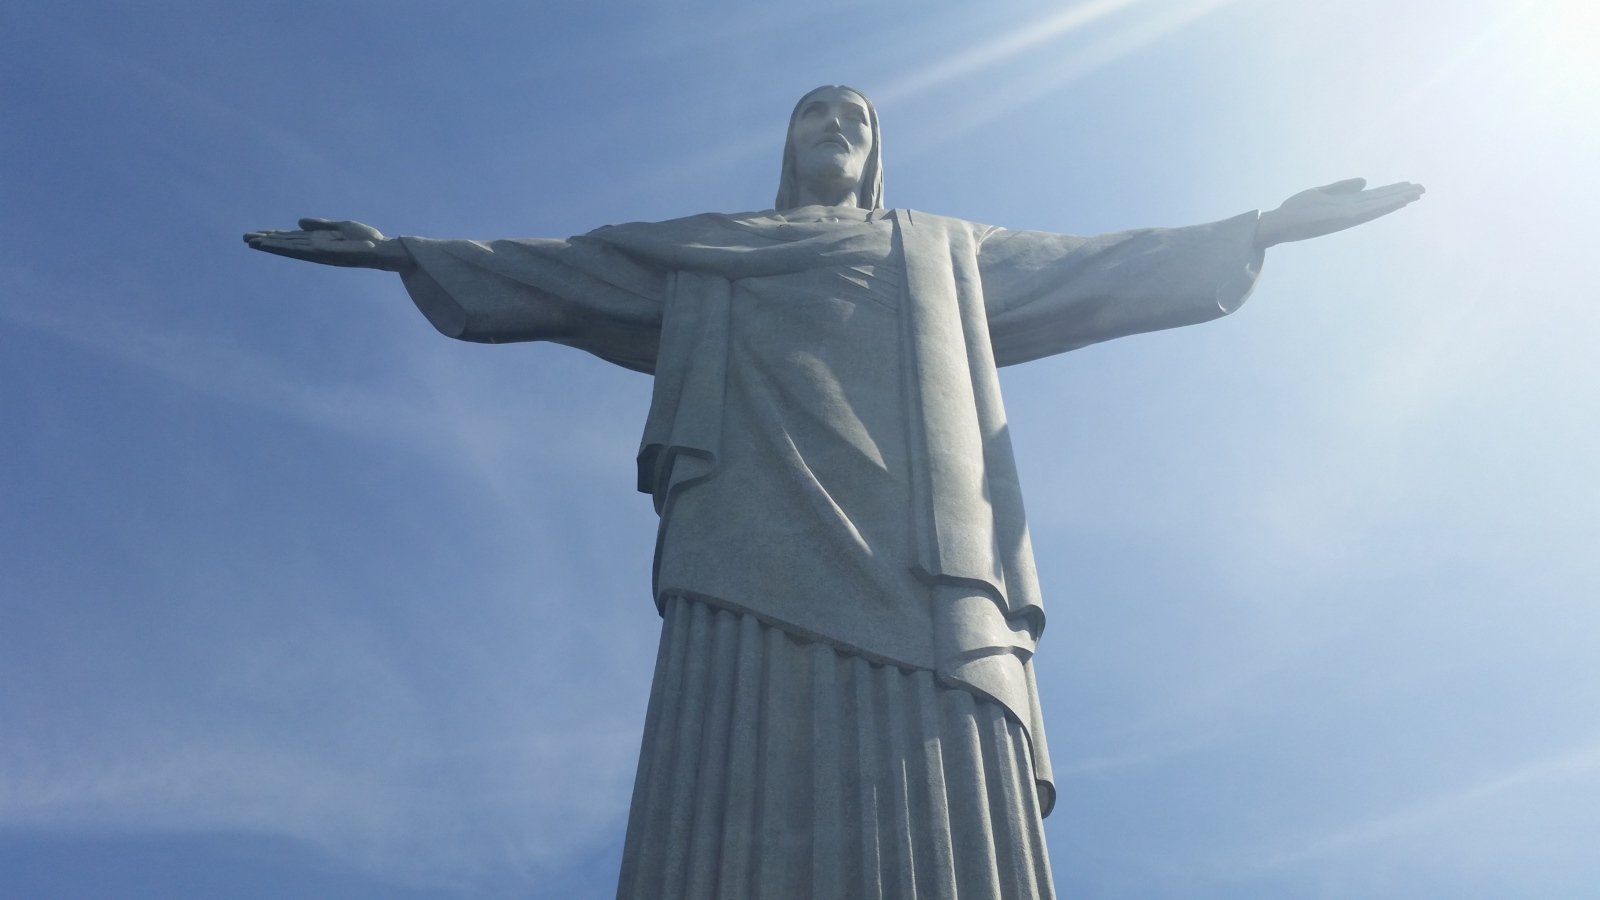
<box><xmin>402</xmin><ymin>207</ymin><xmax>1261</xmax><ymax>890</ymax></box>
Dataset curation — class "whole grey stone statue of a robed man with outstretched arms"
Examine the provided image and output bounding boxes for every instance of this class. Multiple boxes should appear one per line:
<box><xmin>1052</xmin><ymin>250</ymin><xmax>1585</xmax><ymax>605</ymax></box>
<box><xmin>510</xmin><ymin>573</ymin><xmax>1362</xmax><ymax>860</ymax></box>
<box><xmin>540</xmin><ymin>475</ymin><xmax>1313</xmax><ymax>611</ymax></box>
<box><xmin>245</xmin><ymin>86</ymin><xmax>1422</xmax><ymax>900</ymax></box>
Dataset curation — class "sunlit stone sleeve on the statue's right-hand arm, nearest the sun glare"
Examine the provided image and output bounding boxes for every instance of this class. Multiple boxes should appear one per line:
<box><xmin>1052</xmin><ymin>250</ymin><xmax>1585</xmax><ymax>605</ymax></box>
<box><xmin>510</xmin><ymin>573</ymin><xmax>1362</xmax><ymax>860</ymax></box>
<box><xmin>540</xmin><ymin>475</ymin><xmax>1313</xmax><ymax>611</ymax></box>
<box><xmin>978</xmin><ymin>211</ymin><xmax>1262</xmax><ymax>365</ymax></box>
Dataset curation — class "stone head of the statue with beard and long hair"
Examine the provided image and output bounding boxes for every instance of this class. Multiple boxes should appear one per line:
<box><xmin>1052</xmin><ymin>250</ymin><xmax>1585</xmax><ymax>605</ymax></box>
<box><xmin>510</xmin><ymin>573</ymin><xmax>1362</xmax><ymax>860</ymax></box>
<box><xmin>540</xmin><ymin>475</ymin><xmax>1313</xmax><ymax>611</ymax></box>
<box><xmin>776</xmin><ymin>85</ymin><xmax>883</xmax><ymax>210</ymax></box>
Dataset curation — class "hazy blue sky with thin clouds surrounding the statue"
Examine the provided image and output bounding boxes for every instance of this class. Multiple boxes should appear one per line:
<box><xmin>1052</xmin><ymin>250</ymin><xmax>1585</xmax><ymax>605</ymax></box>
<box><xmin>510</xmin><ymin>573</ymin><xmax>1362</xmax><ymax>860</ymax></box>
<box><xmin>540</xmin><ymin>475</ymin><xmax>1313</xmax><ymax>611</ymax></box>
<box><xmin>0</xmin><ymin>0</ymin><xmax>1600</xmax><ymax>900</ymax></box>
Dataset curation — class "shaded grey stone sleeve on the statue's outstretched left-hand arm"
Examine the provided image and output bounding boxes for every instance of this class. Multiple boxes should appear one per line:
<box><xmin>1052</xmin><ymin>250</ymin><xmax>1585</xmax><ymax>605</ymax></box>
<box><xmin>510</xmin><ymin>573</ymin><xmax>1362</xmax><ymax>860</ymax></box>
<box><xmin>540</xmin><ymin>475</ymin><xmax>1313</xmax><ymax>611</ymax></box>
<box><xmin>400</xmin><ymin>235</ymin><xmax>667</xmax><ymax>373</ymax></box>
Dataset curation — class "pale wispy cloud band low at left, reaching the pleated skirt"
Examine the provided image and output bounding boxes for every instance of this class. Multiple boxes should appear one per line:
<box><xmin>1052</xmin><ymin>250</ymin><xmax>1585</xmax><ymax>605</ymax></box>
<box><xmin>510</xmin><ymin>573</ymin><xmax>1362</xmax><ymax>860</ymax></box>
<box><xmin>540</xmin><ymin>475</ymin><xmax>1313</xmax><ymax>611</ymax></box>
<box><xmin>0</xmin><ymin>711</ymin><xmax>637</xmax><ymax>886</ymax></box>
